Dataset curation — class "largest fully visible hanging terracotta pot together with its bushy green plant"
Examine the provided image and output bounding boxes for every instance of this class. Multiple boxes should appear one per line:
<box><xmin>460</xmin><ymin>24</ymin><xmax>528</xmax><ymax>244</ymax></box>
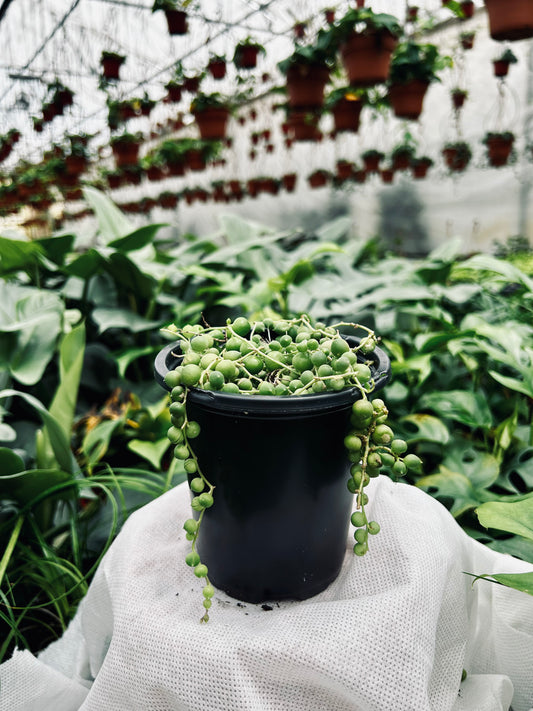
<box><xmin>328</xmin><ymin>7</ymin><xmax>402</xmax><ymax>87</ymax></box>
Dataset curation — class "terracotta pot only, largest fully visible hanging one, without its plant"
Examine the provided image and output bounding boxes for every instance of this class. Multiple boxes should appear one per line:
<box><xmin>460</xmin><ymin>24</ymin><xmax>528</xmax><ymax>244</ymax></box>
<box><xmin>340</xmin><ymin>30</ymin><xmax>397</xmax><ymax>86</ymax></box>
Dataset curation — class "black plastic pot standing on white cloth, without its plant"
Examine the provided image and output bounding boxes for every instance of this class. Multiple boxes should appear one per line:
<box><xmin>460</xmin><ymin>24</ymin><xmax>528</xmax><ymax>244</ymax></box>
<box><xmin>155</xmin><ymin>338</ymin><xmax>390</xmax><ymax>603</ymax></box>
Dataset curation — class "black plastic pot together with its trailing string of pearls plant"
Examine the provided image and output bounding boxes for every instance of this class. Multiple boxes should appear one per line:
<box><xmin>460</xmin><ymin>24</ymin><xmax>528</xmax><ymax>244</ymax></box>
<box><xmin>156</xmin><ymin>316</ymin><xmax>421</xmax><ymax>622</ymax></box>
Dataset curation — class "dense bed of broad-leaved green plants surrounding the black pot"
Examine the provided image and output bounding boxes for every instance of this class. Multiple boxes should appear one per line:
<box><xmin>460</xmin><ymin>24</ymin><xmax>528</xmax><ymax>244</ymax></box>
<box><xmin>0</xmin><ymin>188</ymin><xmax>533</xmax><ymax>658</ymax></box>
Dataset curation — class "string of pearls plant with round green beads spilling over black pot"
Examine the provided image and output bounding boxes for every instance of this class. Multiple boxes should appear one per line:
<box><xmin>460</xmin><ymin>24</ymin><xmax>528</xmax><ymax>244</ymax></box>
<box><xmin>165</xmin><ymin>315</ymin><xmax>422</xmax><ymax>622</ymax></box>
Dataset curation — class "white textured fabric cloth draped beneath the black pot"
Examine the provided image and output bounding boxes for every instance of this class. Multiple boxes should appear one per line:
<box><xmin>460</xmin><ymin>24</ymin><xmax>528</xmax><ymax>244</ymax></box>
<box><xmin>0</xmin><ymin>477</ymin><xmax>533</xmax><ymax>711</ymax></box>
